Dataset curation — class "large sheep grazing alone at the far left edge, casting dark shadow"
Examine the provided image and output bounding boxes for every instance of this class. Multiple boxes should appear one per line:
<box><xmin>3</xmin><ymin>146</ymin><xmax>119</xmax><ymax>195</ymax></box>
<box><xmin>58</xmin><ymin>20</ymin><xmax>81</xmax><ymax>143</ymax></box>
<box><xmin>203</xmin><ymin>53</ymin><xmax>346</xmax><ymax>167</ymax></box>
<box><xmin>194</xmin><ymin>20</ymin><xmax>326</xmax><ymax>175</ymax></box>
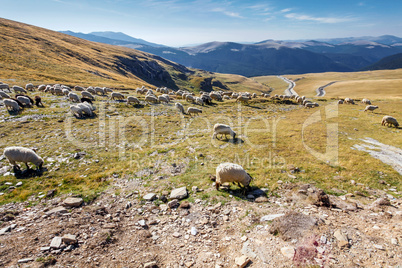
<box><xmin>4</xmin><ymin>146</ymin><xmax>43</xmax><ymax>170</ymax></box>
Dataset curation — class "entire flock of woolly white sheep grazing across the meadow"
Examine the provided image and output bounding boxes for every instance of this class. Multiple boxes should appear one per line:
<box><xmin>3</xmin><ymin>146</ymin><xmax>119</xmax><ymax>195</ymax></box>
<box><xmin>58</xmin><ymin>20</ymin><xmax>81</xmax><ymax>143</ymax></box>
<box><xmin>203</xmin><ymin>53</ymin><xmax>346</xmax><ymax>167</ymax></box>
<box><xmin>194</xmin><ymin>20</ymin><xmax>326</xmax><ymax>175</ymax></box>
<box><xmin>0</xmin><ymin>82</ymin><xmax>399</xmax><ymax>192</ymax></box>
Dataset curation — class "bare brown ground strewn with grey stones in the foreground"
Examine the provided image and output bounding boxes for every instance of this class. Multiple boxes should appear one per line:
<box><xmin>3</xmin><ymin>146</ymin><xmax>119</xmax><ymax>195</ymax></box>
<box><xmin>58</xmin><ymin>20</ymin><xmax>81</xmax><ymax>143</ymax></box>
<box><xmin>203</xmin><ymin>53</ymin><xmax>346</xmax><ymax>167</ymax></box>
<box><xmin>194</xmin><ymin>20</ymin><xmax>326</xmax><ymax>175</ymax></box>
<box><xmin>0</xmin><ymin>173</ymin><xmax>402</xmax><ymax>268</ymax></box>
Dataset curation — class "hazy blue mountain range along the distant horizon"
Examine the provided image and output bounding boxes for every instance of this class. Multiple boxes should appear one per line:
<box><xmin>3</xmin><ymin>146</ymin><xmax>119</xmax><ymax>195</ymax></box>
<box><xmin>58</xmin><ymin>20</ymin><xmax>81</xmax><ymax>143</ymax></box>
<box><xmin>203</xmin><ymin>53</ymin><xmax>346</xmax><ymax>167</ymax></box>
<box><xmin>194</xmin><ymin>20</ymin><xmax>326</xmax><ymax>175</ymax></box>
<box><xmin>59</xmin><ymin>31</ymin><xmax>402</xmax><ymax>77</ymax></box>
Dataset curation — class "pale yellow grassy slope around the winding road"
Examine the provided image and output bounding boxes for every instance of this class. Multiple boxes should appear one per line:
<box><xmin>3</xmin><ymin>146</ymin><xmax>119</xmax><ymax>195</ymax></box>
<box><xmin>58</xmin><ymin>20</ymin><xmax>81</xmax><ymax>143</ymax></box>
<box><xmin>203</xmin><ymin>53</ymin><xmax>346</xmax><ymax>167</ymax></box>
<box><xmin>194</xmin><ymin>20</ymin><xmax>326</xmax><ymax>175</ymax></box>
<box><xmin>254</xmin><ymin>69</ymin><xmax>402</xmax><ymax>99</ymax></box>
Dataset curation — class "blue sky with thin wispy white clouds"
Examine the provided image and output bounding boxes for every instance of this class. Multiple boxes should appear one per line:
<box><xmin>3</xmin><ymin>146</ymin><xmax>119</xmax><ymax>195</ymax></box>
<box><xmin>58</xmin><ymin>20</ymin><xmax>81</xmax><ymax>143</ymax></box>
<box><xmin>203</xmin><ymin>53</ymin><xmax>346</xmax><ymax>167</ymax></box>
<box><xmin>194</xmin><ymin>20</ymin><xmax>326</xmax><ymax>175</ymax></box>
<box><xmin>0</xmin><ymin>0</ymin><xmax>402</xmax><ymax>46</ymax></box>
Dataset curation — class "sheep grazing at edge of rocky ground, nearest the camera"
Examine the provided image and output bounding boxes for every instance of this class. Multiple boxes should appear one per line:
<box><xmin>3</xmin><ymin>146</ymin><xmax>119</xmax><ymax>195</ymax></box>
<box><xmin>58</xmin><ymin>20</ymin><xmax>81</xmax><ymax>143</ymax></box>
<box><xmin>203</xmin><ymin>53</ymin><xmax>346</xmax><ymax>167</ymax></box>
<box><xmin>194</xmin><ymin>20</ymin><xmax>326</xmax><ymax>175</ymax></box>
<box><xmin>215</xmin><ymin>163</ymin><xmax>253</xmax><ymax>191</ymax></box>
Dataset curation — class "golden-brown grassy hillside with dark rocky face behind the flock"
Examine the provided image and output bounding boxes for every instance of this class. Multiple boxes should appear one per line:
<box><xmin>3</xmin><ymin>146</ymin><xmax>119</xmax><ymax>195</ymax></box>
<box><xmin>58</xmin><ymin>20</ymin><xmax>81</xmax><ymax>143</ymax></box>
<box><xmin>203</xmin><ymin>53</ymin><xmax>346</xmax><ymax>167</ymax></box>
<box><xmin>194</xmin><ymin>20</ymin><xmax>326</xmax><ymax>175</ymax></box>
<box><xmin>0</xmin><ymin>18</ymin><xmax>194</xmax><ymax>89</ymax></box>
